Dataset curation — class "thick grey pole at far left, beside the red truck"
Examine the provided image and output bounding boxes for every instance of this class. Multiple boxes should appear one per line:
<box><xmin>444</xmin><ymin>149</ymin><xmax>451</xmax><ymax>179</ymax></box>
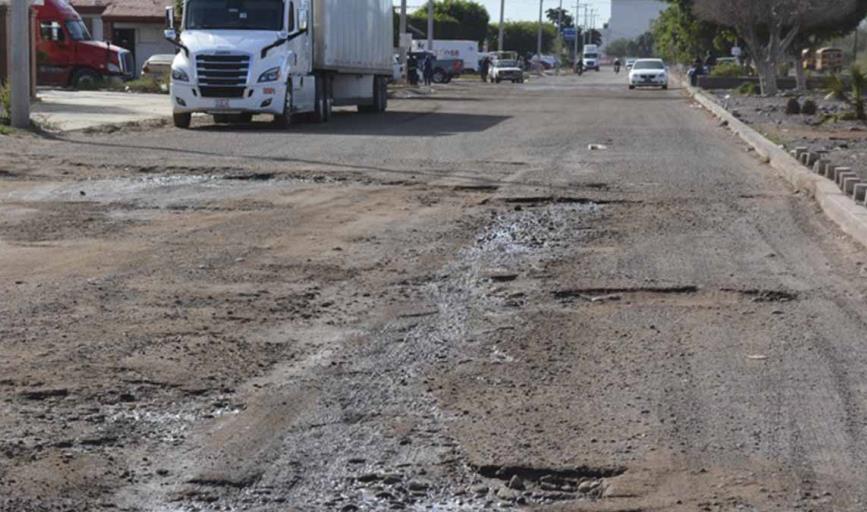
<box><xmin>4</xmin><ymin>0</ymin><xmax>30</xmax><ymax>128</ymax></box>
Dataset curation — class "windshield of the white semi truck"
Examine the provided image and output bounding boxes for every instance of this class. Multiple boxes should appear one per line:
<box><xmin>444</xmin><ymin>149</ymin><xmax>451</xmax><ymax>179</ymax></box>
<box><xmin>184</xmin><ymin>0</ymin><xmax>285</xmax><ymax>31</ymax></box>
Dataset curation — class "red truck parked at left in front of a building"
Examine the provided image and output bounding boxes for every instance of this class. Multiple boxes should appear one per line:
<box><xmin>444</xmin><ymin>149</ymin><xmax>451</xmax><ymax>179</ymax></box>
<box><xmin>35</xmin><ymin>0</ymin><xmax>133</xmax><ymax>87</ymax></box>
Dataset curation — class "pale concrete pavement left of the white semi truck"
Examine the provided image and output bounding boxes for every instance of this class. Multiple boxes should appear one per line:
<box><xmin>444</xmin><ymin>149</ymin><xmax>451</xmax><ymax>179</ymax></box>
<box><xmin>32</xmin><ymin>89</ymin><xmax>172</xmax><ymax>131</ymax></box>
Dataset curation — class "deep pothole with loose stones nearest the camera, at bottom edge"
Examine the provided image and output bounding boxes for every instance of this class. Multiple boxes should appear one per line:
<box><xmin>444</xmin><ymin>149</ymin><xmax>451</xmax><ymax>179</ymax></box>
<box><xmin>475</xmin><ymin>465</ymin><xmax>626</xmax><ymax>502</ymax></box>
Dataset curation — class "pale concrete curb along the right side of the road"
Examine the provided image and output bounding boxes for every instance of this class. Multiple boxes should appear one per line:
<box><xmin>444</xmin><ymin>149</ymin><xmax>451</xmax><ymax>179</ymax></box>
<box><xmin>680</xmin><ymin>80</ymin><xmax>867</xmax><ymax>247</ymax></box>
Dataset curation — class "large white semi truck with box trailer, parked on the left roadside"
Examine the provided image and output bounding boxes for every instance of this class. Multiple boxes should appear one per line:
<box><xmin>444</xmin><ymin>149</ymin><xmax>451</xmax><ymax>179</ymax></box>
<box><xmin>165</xmin><ymin>0</ymin><xmax>393</xmax><ymax>128</ymax></box>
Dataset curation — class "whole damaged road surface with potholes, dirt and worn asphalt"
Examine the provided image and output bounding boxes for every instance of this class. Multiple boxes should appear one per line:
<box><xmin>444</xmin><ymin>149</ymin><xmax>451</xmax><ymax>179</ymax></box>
<box><xmin>0</xmin><ymin>73</ymin><xmax>867</xmax><ymax>512</ymax></box>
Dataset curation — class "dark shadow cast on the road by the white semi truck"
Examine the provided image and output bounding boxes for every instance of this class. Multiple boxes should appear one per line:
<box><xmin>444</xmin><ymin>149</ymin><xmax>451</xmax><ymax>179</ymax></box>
<box><xmin>192</xmin><ymin>111</ymin><xmax>510</xmax><ymax>137</ymax></box>
